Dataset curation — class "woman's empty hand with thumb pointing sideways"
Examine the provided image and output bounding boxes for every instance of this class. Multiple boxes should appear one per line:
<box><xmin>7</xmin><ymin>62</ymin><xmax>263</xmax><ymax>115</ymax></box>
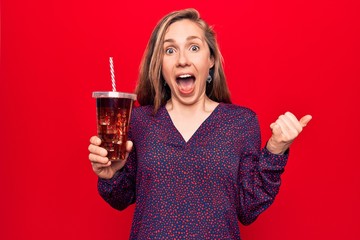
<box><xmin>266</xmin><ymin>112</ymin><xmax>312</xmax><ymax>154</ymax></box>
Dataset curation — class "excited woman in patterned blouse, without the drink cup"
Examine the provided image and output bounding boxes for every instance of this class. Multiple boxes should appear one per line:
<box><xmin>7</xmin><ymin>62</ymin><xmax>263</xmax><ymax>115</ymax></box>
<box><xmin>89</xmin><ymin>9</ymin><xmax>311</xmax><ymax>239</ymax></box>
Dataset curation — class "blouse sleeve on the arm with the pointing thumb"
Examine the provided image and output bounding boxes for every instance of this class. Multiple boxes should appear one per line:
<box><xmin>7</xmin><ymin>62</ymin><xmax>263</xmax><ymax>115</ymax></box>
<box><xmin>238</xmin><ymin>115</ymin><xmax>288</xmax><ymax>225</ymax></box>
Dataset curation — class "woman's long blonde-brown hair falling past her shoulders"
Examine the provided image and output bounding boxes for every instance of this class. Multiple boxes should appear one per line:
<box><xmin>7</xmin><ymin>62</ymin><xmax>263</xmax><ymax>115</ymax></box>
<box><xmin>135</xmin><ymin>8</ymin><xmax>231</xmax><ymax>114</ymax></box>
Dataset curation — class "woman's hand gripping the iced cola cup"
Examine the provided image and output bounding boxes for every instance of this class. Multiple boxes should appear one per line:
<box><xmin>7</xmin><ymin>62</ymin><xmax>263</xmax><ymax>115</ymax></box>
<box><xmin>88</xmin><ymin>136</ymin><xmax>133</xmax><ymax>179</ymax></box>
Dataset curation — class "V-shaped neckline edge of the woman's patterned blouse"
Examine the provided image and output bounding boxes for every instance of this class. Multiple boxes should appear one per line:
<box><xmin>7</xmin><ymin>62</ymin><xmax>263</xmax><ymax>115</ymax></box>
<box><xmin>161</xmin><ymin>103</ymin><xmax>222</xmax><ymax>145</ymax></box>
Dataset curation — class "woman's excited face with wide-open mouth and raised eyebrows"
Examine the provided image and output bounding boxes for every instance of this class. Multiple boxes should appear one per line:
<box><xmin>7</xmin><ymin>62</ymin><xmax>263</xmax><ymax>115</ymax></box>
<box><xmin>162</xmin><ymin>19</ymin><xmax>214</xmax><ymax>105</ymax></box>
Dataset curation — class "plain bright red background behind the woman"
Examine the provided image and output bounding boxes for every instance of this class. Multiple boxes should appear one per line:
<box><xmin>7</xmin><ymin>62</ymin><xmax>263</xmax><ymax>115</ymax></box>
<box><xmin>0</xmin><ymin>0</ymin><xmax>360</xmax><ymax>240</ymax></box>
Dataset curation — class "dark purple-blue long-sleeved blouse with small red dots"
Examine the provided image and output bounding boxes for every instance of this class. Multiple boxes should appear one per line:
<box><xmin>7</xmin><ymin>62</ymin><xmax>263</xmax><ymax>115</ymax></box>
<box><xmin>98</xmin><ymin>103</ymin><xmax>288</xmax><ymax>239</ymax></box>
